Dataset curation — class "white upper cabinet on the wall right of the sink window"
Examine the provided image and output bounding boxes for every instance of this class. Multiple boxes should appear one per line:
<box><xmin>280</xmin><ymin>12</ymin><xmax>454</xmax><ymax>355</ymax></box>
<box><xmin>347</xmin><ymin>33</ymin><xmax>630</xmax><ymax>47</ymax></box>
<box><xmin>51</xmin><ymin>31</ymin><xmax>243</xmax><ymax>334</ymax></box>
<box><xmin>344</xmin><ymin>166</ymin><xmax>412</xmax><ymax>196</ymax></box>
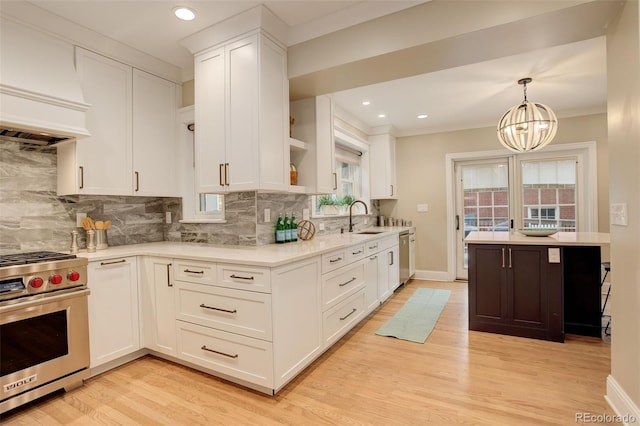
<box><xmin>369</xmin><ymin>134</ymin><xmax>398</xmax><ymax>200</ymax></box>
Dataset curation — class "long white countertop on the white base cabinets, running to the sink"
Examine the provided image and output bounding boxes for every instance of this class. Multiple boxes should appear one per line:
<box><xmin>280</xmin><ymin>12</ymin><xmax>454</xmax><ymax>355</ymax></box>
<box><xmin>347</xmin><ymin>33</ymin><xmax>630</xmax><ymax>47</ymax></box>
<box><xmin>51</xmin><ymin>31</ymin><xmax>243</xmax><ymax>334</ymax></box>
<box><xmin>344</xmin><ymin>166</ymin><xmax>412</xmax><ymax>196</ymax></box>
<box><xmin>77</xmin><ymin>226</ymin><xmax>411</xmax><ymax>267</ymax></box>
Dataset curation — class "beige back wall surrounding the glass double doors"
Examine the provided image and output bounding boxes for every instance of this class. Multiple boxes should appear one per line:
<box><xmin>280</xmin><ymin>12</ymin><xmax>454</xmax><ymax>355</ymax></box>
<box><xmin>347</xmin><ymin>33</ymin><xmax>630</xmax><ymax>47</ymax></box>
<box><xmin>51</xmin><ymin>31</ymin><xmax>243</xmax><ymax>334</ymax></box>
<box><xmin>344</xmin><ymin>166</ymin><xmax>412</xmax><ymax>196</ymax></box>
<box><xmin>380</xmin><ymin>114</ymin><xmax>609</xmax><ymax>272</ymax></box>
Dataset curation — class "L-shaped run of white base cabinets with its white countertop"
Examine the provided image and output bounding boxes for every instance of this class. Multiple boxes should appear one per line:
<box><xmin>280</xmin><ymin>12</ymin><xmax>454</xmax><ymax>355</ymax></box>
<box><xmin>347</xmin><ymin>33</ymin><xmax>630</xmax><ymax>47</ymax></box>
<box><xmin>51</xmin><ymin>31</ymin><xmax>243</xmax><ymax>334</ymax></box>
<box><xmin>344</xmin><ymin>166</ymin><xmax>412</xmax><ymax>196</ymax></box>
<box><xmin>78</xmin><ymin>227</ymin><xmax>409</xmax><ymax>394</ymax></box>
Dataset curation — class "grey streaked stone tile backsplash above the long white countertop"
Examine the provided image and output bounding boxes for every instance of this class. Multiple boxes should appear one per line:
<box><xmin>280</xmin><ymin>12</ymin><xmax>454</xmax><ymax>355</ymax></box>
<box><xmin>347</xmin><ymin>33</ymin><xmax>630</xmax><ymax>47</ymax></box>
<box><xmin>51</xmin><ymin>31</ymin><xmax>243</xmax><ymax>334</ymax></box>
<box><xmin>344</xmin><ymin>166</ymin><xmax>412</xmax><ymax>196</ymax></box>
<box><xmin>0</xmin><ymin>142</ymin><xmax>378</xmax><ymax>254</ymax></box>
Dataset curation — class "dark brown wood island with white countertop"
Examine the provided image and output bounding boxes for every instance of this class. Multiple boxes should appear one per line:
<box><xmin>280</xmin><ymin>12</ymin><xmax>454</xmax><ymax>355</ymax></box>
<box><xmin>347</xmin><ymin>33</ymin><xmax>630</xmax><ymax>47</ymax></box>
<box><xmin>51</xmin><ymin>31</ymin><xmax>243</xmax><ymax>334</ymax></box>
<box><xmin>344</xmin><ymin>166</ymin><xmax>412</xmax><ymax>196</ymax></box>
<box><xmin>466</xmin><ymin>231</ymin><xmax>609</xmax><ymax>342</ymax></box>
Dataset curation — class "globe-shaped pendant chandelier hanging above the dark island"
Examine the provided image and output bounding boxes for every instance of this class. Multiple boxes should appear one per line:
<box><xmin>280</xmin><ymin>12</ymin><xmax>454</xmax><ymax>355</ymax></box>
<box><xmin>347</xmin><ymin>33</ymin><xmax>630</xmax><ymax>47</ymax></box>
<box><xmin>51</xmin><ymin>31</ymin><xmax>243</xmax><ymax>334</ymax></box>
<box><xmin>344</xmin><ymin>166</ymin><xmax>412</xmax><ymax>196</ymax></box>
<box><xmin>498</xmin><ymin>77</ymin><xmax>558</xmax><ymax>152</ymax></box>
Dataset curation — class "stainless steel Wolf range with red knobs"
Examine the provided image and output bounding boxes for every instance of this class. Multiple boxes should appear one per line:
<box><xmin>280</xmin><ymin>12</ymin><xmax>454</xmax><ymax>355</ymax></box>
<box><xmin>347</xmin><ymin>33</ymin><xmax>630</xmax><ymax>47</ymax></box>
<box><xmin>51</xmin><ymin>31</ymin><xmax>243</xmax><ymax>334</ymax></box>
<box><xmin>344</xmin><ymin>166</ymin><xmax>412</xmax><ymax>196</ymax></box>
<box><xmin>0</xmin><ymin>251</ymin><xmax>89</xmax><ymax>413</ymax></box>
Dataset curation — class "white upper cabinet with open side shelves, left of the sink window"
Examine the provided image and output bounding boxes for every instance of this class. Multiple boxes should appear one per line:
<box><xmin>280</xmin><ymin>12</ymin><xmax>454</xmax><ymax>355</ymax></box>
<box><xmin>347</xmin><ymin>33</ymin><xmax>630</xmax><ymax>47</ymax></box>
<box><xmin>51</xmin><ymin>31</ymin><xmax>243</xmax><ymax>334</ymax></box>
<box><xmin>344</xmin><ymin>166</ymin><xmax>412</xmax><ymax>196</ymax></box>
<box><xmin>290</xmin><ymin>95</ymin><xmax>337</xmax><ymax>194</ymax></box>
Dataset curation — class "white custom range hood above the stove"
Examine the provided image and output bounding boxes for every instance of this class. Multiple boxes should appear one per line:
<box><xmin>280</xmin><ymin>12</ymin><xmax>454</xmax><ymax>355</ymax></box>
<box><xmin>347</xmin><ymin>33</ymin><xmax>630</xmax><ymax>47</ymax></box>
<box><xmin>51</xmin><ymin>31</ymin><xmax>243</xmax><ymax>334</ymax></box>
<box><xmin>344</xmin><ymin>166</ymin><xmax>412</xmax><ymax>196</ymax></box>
<box><xmin>0</xmin><ymin>15</ymin><xmax>90</xmax><ymax>145</ymax></box>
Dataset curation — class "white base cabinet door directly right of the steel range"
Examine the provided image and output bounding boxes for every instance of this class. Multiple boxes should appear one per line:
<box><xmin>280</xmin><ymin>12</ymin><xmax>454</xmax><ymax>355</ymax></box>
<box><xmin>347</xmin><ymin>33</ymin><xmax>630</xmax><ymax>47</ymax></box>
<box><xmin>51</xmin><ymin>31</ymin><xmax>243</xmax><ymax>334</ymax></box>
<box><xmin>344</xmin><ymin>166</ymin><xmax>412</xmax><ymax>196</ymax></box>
<box><xmin>88</xmin><ymin>257</ymin><xmax>140</xmax><ymax>369</ymax></box>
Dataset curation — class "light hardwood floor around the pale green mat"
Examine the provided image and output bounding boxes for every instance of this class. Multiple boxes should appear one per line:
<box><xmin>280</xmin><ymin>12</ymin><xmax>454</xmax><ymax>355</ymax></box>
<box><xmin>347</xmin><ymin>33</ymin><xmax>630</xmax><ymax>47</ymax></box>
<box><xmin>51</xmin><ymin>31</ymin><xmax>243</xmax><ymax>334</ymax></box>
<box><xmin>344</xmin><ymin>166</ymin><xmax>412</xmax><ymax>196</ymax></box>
<box><xmin>0</xmin><ymin>281</ymin><xmax>613</xmax><ymax>426</ymax></box>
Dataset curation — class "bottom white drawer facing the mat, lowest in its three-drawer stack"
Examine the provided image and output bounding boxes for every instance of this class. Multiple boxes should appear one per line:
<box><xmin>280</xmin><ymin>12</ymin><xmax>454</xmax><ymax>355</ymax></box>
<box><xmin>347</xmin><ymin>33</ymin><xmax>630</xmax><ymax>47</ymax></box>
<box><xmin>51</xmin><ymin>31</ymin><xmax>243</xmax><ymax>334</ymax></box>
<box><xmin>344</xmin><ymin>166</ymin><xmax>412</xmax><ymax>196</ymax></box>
<box><xmin>322</xmin><ymin>289</ymin><xmax>365</xmax><ymax>347</ymax></box>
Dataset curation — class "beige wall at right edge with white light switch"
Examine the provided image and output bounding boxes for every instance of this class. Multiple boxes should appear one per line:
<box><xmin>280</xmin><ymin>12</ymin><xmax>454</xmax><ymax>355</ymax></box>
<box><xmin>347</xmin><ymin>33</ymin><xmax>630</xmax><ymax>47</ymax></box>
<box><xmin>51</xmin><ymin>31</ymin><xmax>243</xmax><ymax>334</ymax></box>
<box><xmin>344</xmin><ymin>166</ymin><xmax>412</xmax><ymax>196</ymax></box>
<box><xmin>607</xmin><ymin>0</ymin><xmax>640</xmax><ymax>412</ymax></box>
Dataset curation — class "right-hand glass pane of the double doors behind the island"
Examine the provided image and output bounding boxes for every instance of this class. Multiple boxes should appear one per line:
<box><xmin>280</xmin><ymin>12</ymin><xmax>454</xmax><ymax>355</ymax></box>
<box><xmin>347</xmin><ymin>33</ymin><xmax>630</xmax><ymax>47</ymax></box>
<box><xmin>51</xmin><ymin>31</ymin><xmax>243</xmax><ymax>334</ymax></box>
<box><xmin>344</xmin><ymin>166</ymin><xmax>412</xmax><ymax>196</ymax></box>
<box><xmin>521</xmin><ymin>159</ymin><xmax>577</xmax><ymax>232</ymax></box>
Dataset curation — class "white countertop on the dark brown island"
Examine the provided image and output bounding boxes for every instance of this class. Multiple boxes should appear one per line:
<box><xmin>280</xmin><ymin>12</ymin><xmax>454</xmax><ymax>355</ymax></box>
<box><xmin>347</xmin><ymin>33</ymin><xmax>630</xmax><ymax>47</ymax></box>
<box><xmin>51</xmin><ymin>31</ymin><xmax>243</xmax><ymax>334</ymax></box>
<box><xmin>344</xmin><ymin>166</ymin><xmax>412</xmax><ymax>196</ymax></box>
<box><xmin>465</xmin><ymin>231</ymin><xmax>609</xmax><ymax>246</ymax></box>
